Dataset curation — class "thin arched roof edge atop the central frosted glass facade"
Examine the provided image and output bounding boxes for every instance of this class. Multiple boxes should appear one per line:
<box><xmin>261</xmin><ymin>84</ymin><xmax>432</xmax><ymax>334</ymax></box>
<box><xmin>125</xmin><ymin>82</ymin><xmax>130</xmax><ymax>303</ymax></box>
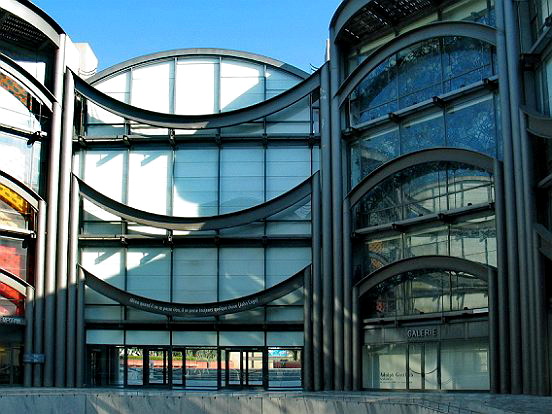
<box><xmin>87</xmin><ymin>48</ymin><xmax>310</xmax><ymax>85</ymax></box>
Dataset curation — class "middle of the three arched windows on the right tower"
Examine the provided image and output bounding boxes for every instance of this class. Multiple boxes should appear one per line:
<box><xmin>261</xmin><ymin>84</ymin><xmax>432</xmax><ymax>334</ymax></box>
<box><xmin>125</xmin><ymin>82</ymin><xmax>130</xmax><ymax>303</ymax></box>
<box><xmin>353</xmin><ymin>162</ymin><xmax>494</xmax><ymax>229</ymax></box>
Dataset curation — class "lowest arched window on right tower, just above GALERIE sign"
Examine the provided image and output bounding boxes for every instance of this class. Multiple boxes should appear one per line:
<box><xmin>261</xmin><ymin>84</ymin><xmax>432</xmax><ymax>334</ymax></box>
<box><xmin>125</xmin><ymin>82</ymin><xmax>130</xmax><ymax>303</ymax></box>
<box><xmin>362</xmin><ymin>270</ymin><xmax>488</xmax><ymax>318</ymax></box>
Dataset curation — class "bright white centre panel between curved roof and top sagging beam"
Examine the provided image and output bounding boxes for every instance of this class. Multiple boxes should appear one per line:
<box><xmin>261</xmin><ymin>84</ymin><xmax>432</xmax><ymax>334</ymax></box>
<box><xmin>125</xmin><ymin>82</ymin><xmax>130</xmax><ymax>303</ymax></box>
<box><xmin>175</xmin><ymin>59</ymin><xmax>218</xmax><ymax>115</ymax></box>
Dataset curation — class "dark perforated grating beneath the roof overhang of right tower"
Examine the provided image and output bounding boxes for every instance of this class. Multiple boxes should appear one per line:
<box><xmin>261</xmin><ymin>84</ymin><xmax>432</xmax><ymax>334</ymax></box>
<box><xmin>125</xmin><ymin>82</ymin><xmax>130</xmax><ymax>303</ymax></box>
<box><xmin>338</xmin><ymin>0</ymin><xmax>441</xmax><ymax>44</ymax></box>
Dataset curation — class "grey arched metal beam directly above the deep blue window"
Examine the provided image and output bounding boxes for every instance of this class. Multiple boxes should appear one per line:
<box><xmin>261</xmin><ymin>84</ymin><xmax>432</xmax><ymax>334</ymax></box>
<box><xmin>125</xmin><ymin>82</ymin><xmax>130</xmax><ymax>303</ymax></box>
<box><xmin>335</xmin><ymin>21</ymin><xmax>496</xmax><ymax>105</ymax></box>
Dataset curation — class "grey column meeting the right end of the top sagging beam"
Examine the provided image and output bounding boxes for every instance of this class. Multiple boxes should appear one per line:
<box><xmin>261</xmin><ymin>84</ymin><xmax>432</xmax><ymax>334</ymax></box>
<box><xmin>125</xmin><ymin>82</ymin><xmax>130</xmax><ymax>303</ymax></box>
<box><xmin>320</xmin><ymin>62</ymin><xmax>334</xmax><ymax>390</ymax></box>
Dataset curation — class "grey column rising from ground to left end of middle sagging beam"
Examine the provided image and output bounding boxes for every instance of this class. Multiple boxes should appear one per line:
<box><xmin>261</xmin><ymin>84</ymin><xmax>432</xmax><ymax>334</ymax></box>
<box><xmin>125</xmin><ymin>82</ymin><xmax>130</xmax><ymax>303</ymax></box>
<box><xmin>67</xmin><ymin>177</ymin><xmax>80</xmax><ymax>387</ymax></box>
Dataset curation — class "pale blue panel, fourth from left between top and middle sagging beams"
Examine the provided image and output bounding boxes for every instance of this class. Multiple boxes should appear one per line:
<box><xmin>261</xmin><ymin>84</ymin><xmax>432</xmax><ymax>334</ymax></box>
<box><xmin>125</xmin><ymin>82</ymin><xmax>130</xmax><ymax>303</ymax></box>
<box><xmin>220</xmin><ymin>146</ymin><xmax>264</xmax><ymax>213</ymax></box>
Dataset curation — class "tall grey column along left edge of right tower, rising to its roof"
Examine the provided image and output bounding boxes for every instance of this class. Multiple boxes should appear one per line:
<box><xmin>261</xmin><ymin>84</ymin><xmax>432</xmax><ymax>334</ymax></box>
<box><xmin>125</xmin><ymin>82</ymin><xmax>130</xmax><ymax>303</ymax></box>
<box><xmin>330</xmin><ymin>27</ymin><xmax>344</xmax><ymax>390</ymax></box>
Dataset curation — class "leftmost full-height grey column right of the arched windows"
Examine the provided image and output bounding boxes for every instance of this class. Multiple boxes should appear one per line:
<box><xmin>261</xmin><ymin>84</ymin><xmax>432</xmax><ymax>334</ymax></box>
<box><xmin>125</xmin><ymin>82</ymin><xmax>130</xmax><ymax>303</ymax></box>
<box><xmin>495</xmin><ymin>0</ymin><xmax>523</xmax><ymax>394</ymax></box>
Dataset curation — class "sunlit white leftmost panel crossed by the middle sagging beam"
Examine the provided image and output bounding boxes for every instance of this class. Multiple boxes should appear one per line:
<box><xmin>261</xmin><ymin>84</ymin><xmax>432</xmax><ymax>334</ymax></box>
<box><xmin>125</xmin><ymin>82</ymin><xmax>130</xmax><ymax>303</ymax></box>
<box><xmin>83</xmin><ymin>149</ymin><xmax>126</xmax><ymax>221</ymax></box>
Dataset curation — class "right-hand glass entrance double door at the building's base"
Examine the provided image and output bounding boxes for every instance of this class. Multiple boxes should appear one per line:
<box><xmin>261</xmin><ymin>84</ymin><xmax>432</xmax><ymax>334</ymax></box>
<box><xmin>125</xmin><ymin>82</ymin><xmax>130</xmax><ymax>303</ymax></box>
<box><xmin>222</xmin><ymin>348</ymin><xmax>268</xmax><ymax>388</ymax></box>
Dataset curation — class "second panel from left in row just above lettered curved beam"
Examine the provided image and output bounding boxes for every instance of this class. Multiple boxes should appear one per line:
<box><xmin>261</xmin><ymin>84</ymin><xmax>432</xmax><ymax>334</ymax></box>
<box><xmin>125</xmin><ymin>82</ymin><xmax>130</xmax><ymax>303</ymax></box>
<box><xmin>127</xmin><ymin>247</ymin><xmax>170</xmax><ymax>301</ymax></box>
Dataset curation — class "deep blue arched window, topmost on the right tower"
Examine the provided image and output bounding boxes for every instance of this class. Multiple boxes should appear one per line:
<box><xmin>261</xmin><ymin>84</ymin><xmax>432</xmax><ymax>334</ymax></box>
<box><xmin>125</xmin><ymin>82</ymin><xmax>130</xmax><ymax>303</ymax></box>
<box><xmin>351</xmin><ymin>36</ymin><xmax>495</xmax><ymax>126</ymax></box>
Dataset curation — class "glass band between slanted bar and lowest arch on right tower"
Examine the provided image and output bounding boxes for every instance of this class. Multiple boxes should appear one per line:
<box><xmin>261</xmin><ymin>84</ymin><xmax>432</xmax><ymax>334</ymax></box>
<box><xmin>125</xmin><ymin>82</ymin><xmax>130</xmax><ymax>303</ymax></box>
<box><xmin>358</xmin><ymin>214</ymin><xmax>496</xmax><ymax>275</ymax></box>
